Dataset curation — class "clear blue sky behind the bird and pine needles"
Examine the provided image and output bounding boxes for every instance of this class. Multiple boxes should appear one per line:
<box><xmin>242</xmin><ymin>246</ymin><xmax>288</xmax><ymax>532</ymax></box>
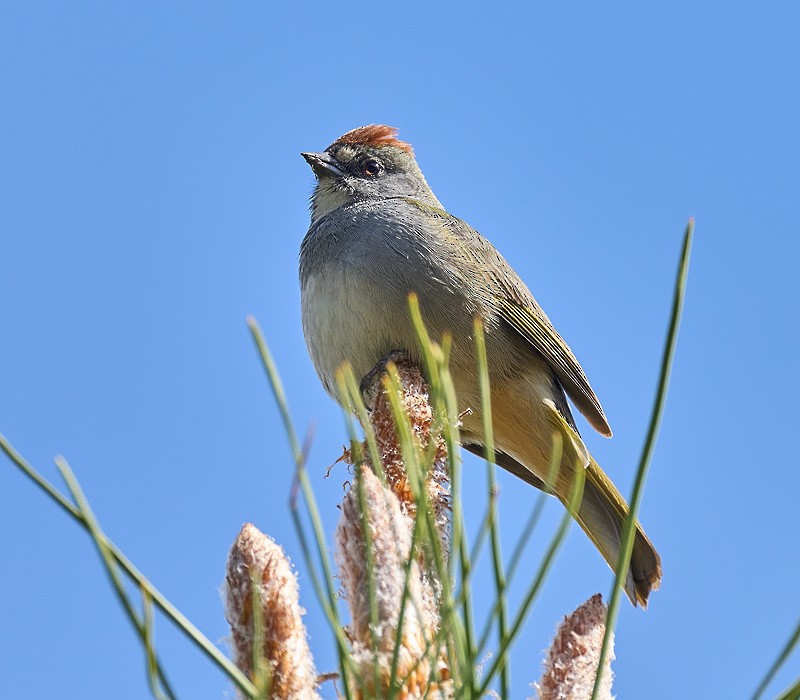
<box><xmin>0</xmin><ymin>0</ymin><xmax>800</xmax><ymax>700</ymax></box>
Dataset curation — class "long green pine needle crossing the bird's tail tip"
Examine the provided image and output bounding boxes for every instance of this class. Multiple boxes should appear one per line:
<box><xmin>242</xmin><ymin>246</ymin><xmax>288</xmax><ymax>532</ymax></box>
<box><xmin>591</xmin><ymin>219</ymin><xmax>694</xmax><ymax>700</ymax></box>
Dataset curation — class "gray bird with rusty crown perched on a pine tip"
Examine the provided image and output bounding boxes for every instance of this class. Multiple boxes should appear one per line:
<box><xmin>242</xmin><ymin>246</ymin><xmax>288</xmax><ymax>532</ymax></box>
<box><xmin>300</xmin><ymin>124</ymin><xmax>661</xmax><ymax>606</ymax></box>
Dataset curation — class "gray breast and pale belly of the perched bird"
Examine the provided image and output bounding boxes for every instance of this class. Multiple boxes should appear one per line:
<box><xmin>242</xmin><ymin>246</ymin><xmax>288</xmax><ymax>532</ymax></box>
<box><xmin>300</xmin><ymin>201</ymin><xmax>477</xmax><ymax>394</ymax></box>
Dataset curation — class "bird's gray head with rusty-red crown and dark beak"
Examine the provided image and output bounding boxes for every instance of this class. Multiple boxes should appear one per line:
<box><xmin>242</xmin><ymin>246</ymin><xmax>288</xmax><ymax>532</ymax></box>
<box><xmin>302</xmin><ymin>124</ymin><xmax>442</xmax><ymax>223</ymax></box>
